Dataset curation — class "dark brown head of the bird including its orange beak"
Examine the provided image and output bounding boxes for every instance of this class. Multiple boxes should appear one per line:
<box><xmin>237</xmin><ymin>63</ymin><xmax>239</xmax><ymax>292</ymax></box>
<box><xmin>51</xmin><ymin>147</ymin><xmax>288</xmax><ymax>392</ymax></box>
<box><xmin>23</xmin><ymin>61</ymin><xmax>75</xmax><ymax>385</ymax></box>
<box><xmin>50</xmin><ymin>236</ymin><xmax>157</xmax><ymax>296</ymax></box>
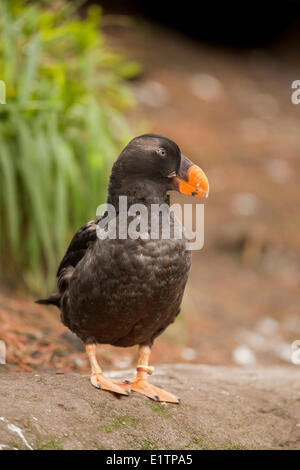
<box><xmin>108</xmin><ymin>134</ymin><xmax>209</xmax><ymax>202</ymax></box>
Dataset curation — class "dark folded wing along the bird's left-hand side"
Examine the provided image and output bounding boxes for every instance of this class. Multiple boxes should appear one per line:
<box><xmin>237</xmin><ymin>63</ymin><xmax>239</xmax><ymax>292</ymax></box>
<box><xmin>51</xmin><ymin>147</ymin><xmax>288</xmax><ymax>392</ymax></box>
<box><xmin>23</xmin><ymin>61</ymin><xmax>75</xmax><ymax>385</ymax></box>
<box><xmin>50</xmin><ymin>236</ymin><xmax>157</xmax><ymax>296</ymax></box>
<box><xmin>56</xmin><ymin>216</ymin><xmax>103</xmax><ymax>277</ymax></box>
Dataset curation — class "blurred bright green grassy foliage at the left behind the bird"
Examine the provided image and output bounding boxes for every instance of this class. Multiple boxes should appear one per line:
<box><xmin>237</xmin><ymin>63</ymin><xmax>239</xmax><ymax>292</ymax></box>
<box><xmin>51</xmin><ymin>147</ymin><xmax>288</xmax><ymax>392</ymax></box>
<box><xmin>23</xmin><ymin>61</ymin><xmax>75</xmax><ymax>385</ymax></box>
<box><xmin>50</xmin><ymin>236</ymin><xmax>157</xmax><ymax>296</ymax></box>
<box><xmin>0</xmin><ymin>0</ymin><xmax>138</xmax><ymax>291</ymax></box>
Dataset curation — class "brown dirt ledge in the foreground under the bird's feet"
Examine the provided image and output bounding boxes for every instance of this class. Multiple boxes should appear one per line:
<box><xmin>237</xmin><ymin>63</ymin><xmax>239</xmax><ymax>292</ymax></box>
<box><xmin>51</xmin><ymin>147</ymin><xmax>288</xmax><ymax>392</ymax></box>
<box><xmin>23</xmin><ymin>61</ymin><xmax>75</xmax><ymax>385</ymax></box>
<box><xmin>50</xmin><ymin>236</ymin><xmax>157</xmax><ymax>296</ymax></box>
<box><xmin>0</xmin><ymin>365</ymin><xmax>300</xmax><ymax>450</ymax></box>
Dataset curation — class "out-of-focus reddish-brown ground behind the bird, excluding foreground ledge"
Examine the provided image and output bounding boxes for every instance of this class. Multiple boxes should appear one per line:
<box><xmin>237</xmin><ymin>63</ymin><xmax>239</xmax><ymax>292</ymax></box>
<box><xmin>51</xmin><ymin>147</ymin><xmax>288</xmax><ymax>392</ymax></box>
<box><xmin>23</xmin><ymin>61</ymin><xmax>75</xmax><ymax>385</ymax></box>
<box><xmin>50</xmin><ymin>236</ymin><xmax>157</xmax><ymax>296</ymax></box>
<box><xmin>0</xmin><ymin>18</ymin><xmax>300</xmax><ymax>371</ymax></box>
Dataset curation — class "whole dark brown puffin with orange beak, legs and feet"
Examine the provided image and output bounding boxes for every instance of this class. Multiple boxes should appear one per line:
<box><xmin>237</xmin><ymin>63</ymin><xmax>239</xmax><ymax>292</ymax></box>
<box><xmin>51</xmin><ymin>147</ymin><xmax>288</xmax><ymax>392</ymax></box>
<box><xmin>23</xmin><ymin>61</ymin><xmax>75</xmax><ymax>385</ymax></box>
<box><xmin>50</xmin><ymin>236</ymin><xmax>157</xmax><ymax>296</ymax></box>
<box><xmin>37</xmin><ymin>134</ymin><xmax>208</xmax><ymax>403</ymax></box>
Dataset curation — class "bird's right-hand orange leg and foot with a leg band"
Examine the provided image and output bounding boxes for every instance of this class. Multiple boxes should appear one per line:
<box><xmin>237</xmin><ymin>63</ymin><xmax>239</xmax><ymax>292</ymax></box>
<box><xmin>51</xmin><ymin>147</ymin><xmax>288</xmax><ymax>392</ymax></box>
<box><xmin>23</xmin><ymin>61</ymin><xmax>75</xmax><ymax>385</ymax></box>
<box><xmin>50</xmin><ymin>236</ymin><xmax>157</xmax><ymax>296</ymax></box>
<box><xmin>131</xmin><ymin>345</ymin><xmax>179</xmax><ymax>403</ymax></box>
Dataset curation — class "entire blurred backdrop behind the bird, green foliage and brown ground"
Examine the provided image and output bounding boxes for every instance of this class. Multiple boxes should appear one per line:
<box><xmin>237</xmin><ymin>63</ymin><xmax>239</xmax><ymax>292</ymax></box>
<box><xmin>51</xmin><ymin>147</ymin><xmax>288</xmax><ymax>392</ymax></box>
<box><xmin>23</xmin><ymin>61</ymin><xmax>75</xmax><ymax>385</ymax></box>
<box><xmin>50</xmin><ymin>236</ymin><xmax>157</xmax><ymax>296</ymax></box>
<box><xmin>0</xmin><ymin>0</ymin><xmax>300</xmax><ymax>372</ymax></box>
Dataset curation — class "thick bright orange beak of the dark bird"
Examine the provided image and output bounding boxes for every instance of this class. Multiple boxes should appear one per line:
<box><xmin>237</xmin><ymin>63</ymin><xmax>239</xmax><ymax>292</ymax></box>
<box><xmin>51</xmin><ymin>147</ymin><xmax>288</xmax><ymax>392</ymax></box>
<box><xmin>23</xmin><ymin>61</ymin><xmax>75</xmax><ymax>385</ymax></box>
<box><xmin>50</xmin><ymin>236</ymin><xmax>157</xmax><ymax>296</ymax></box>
<box><xmin>173</xmin><ymin>155</ymin><xmax>209</xmax><ymax>197</ymax></box>
